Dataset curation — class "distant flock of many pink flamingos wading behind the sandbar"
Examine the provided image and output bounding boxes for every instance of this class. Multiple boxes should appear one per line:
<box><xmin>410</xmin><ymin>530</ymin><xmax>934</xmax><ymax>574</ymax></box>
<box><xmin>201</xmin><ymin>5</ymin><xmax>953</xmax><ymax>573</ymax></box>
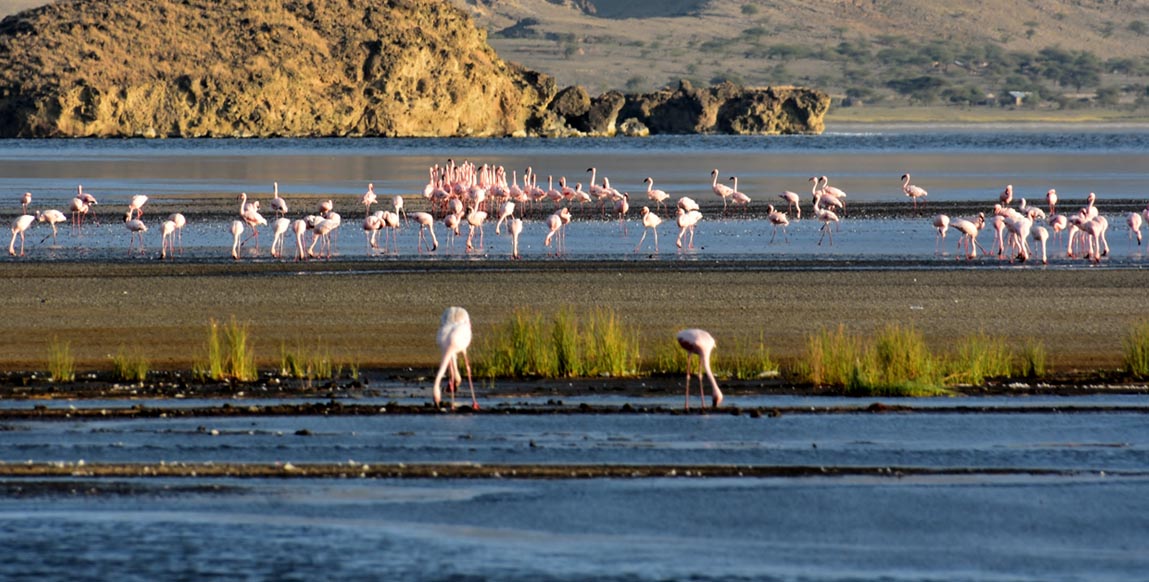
<box><xmin>8</xmin><ymin>160</ymin><xmax>1149</xmax><ymax>263</ymax></box>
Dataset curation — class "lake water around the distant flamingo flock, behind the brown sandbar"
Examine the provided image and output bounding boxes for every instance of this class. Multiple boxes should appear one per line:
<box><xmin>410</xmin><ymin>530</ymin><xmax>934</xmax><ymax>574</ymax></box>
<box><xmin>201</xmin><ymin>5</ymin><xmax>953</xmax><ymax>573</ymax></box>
<box><xmin>0</xmin><ymin>129</ymin><xmax>1149</xmax><ymax>266</ymax></box>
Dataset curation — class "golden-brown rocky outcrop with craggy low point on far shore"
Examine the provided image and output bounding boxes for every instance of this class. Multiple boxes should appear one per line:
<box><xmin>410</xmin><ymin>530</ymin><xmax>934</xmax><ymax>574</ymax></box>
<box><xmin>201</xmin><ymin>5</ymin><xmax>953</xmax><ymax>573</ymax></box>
<box><xmin>0</xmin><ymin>0</ymin><xmax>830</xmax><ymax>137</ymax></box>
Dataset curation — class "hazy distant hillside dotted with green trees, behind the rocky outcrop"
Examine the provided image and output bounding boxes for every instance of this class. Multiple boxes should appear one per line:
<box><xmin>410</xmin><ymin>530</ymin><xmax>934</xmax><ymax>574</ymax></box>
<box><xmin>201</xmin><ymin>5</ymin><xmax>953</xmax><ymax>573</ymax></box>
<box><xmin>454</xmin><ymin>0</ymin><xmax>1149</xmax><ymax>108</ymax></box>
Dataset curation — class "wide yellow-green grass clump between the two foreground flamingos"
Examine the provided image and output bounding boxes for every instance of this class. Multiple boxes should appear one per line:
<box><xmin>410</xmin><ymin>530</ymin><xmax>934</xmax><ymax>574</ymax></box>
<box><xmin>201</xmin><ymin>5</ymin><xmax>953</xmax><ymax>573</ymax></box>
<box><xmin>475</xmin><ymin>308</ymin><xmax>639</xmax><ymax>378</ymax></box>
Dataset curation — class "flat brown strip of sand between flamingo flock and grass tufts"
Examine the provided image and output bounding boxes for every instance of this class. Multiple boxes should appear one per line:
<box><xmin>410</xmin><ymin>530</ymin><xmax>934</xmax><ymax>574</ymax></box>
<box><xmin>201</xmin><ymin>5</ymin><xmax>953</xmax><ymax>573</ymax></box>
<box><xmin>0</xmin><ymin>257</ymin><xmax>1149</xmax><ymax>373</ymax></box>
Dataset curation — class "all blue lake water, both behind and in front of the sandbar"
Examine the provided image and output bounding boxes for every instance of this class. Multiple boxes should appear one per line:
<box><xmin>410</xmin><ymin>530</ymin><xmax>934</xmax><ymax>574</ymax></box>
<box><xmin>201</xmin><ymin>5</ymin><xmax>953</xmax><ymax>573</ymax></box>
<box><xmin>0</xmin><ymin>127</ymin><xmax>1149</xmax><ymax>581</ymax></box>
